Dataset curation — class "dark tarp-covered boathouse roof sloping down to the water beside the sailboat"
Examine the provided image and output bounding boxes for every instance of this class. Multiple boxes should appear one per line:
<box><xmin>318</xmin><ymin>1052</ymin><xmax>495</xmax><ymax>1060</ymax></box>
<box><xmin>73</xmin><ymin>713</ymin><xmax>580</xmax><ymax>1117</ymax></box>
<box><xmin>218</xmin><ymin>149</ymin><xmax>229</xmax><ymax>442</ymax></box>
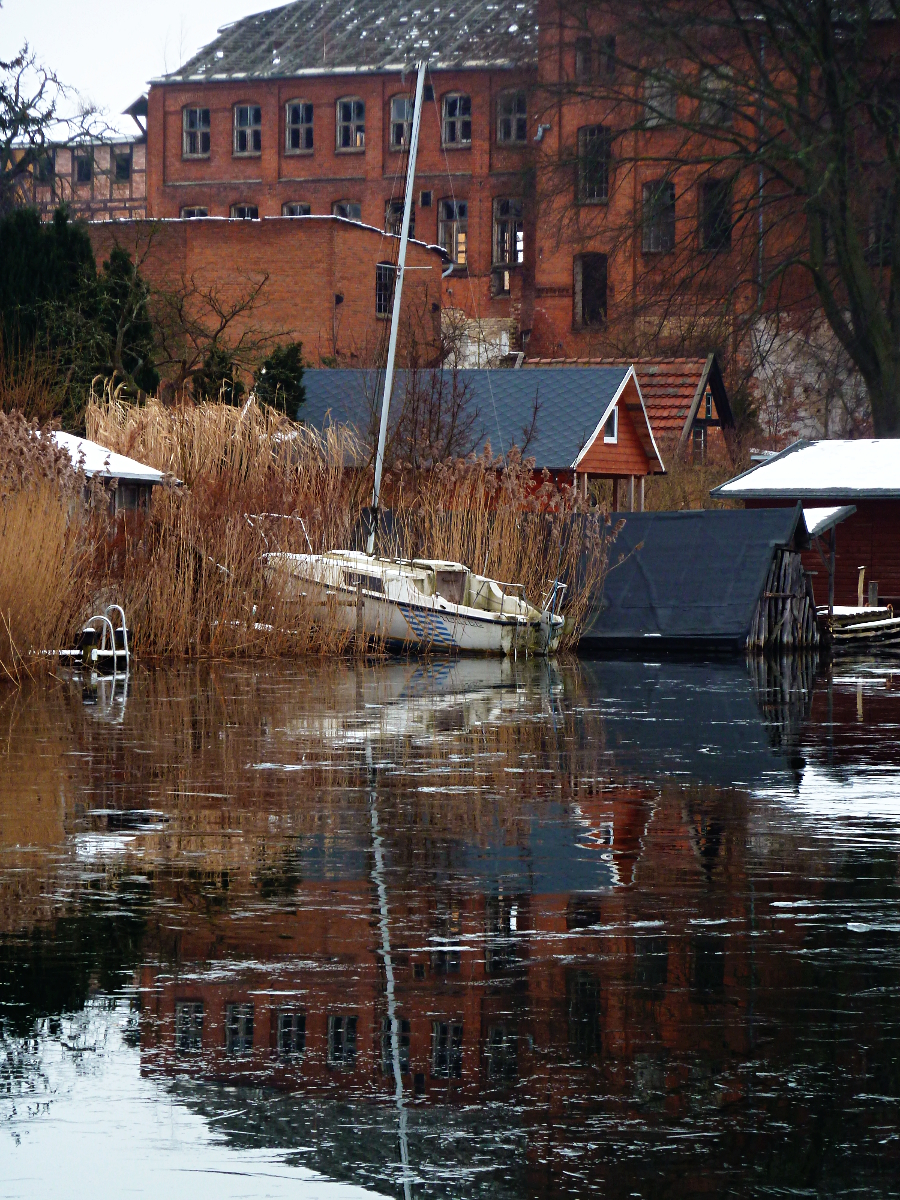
<box><xmin>581</xmin><ymin>504</ymin><xmax>809</xmax><ymax>653</ymax></box>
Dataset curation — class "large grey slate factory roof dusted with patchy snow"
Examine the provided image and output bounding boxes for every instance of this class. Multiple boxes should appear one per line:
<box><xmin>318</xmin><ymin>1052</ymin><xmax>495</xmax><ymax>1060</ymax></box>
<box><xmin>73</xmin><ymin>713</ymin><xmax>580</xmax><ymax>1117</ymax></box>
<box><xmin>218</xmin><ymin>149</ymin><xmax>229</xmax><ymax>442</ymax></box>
<box><xmin>155</xmin><ymin>0</ymin><xmax>538</xmax><ymax>83</ymax></box>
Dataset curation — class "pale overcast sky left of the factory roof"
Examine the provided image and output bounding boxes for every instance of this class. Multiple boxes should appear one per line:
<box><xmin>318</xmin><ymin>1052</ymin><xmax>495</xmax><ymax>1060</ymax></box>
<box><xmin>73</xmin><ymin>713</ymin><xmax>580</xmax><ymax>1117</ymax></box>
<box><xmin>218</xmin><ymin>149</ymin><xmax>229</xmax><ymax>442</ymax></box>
<box><xmin>0</xmin><ymin>0</ymin><xmax>271</xmax><ymax>131</ymax></box>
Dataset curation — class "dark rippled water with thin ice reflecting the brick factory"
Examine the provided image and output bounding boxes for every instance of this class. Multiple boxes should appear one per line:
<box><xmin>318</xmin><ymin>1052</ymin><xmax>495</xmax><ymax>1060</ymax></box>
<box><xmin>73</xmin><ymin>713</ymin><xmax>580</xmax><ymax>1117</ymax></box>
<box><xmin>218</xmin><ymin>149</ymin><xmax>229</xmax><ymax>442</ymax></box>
<box><xmin>0</xmin><ymin>661</ymin><xmax>900</xmax><ymax>1200</ymax></box>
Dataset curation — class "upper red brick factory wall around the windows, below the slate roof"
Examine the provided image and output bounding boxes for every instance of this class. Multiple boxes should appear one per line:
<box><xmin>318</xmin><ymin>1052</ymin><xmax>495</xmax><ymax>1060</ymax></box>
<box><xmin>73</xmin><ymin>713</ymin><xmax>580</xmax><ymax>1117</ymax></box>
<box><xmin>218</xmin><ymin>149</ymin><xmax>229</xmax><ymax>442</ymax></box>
<box><xmin>148</xmin><ymin>71</ymin><xmax>534</xmax><ymax>331</ymax></box>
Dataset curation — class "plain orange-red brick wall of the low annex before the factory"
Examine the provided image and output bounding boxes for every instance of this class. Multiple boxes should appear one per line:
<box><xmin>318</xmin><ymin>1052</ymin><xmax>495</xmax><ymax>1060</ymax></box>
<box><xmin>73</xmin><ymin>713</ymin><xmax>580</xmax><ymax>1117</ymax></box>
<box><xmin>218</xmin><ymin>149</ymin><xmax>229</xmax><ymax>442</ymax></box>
<box><xmin>89</xmin><ymin>217</ymin><xmax>443</xmax><ymax>366</ymax></box>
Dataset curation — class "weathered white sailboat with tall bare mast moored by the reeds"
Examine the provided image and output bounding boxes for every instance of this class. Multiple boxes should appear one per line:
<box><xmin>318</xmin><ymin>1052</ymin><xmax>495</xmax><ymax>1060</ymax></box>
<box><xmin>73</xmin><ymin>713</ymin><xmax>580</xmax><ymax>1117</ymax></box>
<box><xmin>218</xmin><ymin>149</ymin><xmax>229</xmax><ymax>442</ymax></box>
<box><xmin>265</xmin><ymin>61</ymin><xmax>565</xmax><ymax>654</ymax></box>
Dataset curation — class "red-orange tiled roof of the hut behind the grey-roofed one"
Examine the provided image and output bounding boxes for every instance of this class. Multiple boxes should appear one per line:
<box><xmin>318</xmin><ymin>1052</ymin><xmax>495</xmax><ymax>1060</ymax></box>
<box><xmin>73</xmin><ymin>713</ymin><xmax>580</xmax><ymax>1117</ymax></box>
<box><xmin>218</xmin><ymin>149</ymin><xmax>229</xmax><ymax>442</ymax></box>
<box><xmin>522</xmin><ymin>354</ymin><xmax>734</xmax><ymax>443</ymax></box>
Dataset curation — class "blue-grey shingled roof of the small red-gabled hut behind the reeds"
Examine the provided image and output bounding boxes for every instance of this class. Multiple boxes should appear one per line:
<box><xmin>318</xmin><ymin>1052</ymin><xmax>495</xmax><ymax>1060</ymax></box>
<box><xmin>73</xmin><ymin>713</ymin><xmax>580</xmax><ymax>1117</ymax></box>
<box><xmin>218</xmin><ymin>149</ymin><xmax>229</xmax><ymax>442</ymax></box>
<box><xmin>299</xmin><ymin>366</ymin><xmax>630</xmax><ymax>470</ymax></box>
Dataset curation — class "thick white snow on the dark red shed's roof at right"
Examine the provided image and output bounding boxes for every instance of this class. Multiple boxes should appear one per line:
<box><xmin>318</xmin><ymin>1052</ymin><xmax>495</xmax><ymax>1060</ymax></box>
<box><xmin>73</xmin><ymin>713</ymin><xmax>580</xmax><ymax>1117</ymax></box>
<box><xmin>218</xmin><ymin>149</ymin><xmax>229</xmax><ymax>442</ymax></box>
<box><xmin>710</xmin><ymin>438</ymin><xmax>900</xmax><ymax>500</ymax></box>
